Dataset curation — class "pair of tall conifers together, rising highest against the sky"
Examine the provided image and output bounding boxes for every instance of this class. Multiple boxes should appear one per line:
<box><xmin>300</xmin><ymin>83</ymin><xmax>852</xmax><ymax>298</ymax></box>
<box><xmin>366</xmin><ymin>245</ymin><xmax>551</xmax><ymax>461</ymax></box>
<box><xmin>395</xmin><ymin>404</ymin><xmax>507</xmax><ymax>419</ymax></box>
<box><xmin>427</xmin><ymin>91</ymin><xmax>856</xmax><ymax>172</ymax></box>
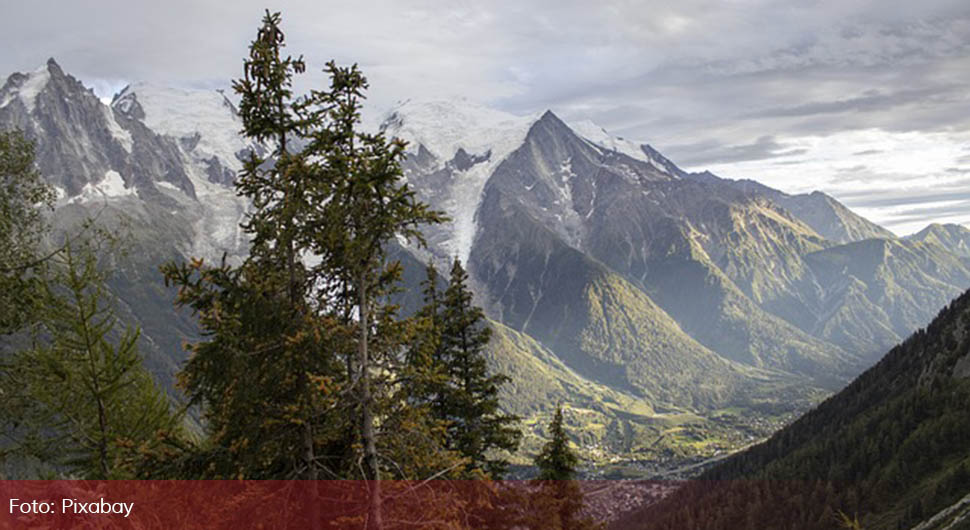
<box><xmin>158</xmin><ymin>12</ymin><xmax>460</xmax><ymax>504</ymax></box>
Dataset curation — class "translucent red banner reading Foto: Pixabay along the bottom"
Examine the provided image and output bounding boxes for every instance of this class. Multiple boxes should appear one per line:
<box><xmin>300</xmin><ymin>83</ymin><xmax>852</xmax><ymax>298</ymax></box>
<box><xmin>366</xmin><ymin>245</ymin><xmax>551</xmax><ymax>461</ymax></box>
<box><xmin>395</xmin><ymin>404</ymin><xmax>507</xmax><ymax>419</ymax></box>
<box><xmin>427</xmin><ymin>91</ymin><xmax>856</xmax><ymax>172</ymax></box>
<box><xmin>0</xmin><ymin>480</ymin><xmax>676</xmax><ymax>530</ymax></box>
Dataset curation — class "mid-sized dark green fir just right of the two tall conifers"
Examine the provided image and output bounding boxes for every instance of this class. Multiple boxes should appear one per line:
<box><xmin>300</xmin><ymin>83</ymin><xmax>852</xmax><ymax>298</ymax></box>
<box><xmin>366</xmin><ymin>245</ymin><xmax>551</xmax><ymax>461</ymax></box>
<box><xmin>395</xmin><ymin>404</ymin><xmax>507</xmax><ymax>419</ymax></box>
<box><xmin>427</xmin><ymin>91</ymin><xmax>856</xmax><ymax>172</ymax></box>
<box><xmin>434</xmin><ymin>258</ymin><xmax>521</xmax><ymax>477</ymax></box>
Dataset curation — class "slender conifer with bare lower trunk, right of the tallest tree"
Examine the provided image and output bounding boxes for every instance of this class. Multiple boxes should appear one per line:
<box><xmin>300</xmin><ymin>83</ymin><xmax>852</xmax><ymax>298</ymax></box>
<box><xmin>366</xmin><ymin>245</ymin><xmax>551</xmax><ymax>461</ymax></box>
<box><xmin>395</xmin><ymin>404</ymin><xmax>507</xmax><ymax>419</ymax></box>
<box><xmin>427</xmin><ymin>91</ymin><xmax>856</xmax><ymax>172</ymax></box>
<box><xmin>298</xmin><ymin>56</ymin><xmax>443</xmax><ymax>527</ymax></box>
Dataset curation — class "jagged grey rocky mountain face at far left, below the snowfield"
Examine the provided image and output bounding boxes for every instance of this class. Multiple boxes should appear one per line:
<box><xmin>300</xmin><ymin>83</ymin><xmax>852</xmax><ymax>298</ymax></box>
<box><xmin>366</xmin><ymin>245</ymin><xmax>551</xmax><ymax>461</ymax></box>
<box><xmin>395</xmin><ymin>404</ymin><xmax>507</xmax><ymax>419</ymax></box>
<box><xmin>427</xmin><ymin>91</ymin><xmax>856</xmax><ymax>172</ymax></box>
<box><xmin>0</xmin><ymin>59</ymin><xmax>246</xmax><ymax>386</ymax></box>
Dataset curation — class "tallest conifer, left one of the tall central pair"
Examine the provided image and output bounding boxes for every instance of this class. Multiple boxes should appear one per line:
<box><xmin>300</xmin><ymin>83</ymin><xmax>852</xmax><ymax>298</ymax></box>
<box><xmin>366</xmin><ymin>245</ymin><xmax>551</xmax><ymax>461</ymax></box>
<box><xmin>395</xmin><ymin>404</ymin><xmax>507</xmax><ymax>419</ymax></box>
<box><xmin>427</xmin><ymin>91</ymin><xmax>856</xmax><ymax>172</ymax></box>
<box><xmin>163</xmin><ymin>12</ymin><xmax>354</xmax><ymax>479</ymax></box>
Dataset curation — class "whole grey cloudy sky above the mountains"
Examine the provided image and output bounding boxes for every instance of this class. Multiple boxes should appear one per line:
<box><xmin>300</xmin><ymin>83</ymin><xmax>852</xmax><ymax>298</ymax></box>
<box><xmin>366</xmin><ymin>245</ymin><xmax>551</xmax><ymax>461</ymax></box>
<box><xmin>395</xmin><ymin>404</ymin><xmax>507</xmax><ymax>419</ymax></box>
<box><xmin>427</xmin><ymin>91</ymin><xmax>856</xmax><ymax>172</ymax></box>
<box><xmin>0</xmin><ymin>0</ymin><xmax>970</xmax><ymax>234</ymax></box>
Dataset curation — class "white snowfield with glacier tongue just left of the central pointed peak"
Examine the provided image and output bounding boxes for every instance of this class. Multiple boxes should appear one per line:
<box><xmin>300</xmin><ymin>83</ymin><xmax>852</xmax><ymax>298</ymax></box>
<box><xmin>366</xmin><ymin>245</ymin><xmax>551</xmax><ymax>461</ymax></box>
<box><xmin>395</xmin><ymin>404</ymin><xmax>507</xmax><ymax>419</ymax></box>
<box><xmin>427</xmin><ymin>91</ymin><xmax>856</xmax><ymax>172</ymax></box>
<box><xmin>381</xmin><ymin>100</ymin><xmax>541</xmax><ymax>261</ymax></box>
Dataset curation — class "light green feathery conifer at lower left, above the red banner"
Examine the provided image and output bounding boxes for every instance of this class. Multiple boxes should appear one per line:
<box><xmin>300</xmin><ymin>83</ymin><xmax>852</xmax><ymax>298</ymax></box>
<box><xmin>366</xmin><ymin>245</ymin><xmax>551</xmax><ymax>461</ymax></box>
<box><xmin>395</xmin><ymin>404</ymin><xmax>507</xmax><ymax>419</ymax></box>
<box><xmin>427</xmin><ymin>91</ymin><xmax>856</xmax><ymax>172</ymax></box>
<box><xmin>0</xmin><ymin>233</ymin><xmax>181</xmax><ymax>479</ymax></box>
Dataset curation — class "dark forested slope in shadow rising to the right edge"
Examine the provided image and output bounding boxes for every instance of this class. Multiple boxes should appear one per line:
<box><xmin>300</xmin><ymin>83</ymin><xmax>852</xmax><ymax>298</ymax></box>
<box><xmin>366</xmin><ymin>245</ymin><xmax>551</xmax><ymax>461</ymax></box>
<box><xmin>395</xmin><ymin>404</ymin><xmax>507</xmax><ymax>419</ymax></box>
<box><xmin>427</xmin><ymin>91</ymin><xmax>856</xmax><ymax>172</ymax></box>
<box><xmin>629</xmin><ymin>292</ymin><xmax>970</xmax><ymax>529</ymax></box>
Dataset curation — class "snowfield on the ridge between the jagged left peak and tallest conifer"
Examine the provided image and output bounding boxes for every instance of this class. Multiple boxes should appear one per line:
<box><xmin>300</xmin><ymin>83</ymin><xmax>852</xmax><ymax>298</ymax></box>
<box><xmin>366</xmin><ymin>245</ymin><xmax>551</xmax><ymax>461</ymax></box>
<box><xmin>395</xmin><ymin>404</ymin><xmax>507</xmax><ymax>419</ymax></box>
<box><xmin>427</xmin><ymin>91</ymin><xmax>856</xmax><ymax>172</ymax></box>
<box><xmin>114</xmin><ymin>83</ymin><xmax>248</xmax><ymax>171</ymax></box>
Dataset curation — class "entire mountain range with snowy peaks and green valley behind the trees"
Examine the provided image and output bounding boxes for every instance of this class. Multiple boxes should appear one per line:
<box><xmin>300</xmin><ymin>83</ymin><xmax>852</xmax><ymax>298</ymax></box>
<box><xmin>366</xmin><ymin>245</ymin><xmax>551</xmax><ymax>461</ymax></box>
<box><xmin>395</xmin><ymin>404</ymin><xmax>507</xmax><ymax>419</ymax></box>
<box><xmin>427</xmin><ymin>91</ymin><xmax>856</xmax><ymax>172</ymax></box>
<box><xmin>0</xmin><ymin>59</ymin><xmax>970</xmax><ymax>476</ymax></box>
